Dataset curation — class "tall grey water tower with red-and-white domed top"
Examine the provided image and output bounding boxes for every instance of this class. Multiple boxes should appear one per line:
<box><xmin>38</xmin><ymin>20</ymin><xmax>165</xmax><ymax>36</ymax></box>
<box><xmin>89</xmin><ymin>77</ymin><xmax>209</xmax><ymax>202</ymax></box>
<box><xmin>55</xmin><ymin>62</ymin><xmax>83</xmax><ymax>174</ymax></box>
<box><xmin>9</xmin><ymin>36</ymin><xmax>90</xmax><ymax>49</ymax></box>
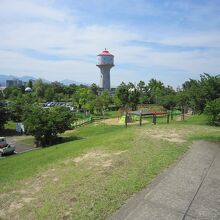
<box><xmin>96</xmin><ymin>49</ymin><xmax>114</xmax><ymax>90</ymax></box>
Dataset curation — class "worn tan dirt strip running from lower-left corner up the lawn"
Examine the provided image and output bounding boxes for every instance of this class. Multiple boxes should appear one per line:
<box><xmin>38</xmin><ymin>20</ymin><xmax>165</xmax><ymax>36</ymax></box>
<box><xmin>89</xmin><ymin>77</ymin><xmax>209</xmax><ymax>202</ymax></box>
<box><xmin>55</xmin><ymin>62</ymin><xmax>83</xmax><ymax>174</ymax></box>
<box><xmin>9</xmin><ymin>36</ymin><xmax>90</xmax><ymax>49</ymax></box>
<box><xmin>0</xmin><ymin>150</ymin><xmax>126</xmax><ymax>219</ymax></box>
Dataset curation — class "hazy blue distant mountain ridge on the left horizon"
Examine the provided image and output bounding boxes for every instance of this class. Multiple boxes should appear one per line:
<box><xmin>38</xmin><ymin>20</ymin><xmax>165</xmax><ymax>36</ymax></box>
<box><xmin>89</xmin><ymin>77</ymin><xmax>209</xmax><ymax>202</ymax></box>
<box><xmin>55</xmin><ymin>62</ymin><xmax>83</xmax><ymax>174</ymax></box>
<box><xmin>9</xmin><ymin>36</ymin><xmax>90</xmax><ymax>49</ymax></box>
<box><xmin>0</xmin><ymin>75</ymin><xmax>86</xmax><ymax>86</ymax></box>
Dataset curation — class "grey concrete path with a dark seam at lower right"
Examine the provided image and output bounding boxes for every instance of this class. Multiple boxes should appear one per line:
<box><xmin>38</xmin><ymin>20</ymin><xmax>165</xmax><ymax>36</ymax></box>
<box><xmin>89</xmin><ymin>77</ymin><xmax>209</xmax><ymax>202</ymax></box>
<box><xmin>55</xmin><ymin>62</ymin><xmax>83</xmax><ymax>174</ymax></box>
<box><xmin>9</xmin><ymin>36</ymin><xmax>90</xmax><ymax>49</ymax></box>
<box><xmin>109</xmin><ymin>141</ymin><xmax>220</xmax><ymax>220</ymax></box>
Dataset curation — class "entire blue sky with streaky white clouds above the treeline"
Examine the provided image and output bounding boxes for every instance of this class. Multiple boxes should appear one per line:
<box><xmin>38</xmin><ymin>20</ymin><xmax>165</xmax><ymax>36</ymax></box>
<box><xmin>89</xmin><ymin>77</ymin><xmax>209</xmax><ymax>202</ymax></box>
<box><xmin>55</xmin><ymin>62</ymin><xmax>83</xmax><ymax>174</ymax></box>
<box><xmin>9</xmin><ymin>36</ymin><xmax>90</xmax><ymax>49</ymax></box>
<box><xmin>0</xmin><ymin>0</ymin><xmax>220</xmax><ymax>87</ymax></box>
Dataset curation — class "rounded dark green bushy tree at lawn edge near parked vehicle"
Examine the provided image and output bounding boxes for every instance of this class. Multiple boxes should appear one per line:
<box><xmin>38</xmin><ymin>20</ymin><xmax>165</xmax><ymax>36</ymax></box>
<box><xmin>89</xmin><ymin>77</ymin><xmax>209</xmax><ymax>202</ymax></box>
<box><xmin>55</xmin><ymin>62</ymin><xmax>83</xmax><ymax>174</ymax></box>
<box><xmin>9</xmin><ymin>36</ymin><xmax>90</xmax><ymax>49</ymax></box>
<box><xmin>23</xmin><ymin>106</ymin><xmax>72</xmax><ymax>147</ymax></box>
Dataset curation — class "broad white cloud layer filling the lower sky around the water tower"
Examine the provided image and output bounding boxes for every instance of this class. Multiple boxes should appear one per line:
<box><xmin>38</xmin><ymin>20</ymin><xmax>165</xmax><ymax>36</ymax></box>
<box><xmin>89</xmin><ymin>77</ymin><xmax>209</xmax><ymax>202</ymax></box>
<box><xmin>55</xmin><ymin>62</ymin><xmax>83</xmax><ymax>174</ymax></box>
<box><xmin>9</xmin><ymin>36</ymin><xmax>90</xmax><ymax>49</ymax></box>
<box><xmin>0</xmin><ymin>0</ymin><xmax>220</xmax><ymax>85</ymax></box>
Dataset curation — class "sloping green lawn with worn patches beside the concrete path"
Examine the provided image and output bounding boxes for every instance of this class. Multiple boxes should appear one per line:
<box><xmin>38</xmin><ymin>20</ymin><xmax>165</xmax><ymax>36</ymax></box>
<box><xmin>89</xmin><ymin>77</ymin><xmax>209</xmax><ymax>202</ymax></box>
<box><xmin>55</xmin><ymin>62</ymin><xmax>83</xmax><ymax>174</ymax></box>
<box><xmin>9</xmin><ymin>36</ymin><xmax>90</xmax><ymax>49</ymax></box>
<box><xmin>0</xmin><ymin>116</ymin><xmax>220</xmax><ymax>219</ymax></box>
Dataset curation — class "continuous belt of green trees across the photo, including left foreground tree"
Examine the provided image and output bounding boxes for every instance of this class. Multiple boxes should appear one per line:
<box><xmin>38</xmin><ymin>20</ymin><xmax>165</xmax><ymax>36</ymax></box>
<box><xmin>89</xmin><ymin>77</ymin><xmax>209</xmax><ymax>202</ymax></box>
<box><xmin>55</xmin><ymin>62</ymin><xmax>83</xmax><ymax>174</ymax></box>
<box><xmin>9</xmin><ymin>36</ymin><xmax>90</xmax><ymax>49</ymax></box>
<box><xmin>0</xmin><ymin>73</ymin><xmax>220</xmax><ymax>142</ymax></box>
